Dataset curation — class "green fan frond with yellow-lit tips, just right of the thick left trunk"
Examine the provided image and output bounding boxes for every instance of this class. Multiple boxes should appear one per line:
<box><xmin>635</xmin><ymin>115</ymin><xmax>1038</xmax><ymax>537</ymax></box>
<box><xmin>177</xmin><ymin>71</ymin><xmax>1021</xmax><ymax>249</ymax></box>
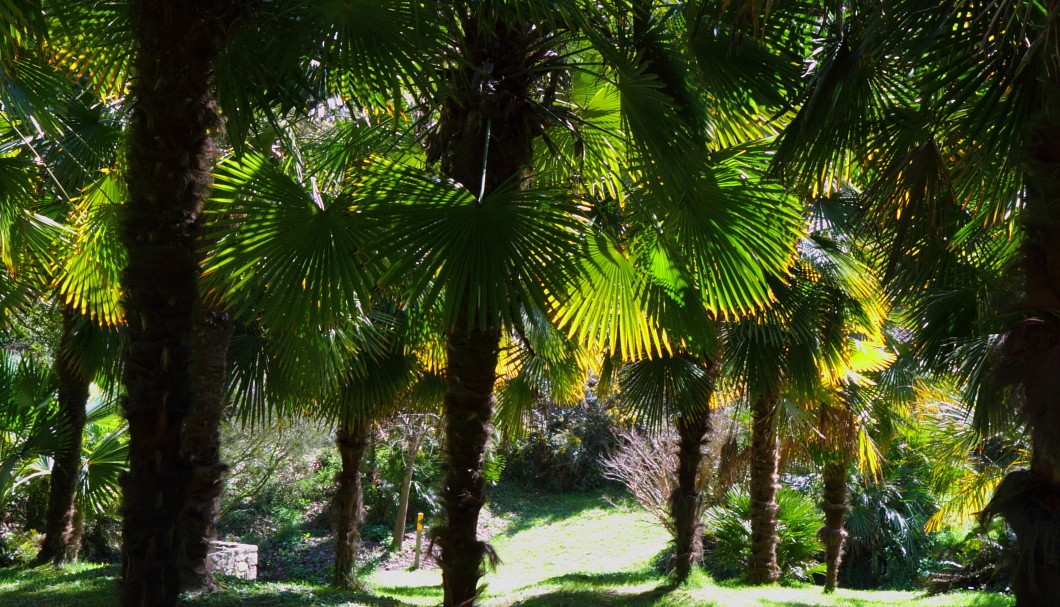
<box><xmin>202</xmin><ymin>154</ymin><xmax>375</xmax><ymax>331</ymax></box>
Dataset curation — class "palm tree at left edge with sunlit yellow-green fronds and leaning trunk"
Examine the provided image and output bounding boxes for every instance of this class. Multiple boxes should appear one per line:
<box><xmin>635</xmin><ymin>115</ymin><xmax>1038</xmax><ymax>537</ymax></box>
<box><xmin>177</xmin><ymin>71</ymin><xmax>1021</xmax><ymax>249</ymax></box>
<box><xmin>0</xmin><ymin>32</ymin><xmax>128</xmax><ymax>563</ymax></box>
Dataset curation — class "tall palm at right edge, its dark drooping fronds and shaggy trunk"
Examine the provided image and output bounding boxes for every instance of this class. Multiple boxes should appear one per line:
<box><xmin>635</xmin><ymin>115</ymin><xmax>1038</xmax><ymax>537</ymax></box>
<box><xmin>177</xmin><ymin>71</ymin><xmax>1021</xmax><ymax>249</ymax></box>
<box><xmin>778</xmin><ymin>0</ymin><xmax>1060</xmax><ymax>605</ymax></box>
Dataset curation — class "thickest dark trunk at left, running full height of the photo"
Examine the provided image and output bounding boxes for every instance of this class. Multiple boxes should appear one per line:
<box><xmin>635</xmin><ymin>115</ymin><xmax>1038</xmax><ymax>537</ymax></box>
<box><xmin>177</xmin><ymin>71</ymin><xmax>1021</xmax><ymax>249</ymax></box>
<box><xmin>121</xmin><ymin>0</ymin><xmax>237</xmax><ymax>607</ymax></box>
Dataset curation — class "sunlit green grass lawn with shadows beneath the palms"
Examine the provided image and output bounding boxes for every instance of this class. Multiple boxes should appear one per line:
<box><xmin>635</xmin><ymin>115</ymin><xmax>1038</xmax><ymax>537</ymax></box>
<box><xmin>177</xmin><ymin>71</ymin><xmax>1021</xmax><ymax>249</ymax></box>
<box><xmin>0</xmin><ymin>492</ymin><xmax>1013</xmax><ymax>607</ymax></box>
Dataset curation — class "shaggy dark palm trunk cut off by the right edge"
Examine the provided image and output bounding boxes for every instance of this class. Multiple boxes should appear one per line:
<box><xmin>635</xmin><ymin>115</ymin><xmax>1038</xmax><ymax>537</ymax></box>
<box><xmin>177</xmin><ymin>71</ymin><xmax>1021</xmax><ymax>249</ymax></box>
<box><xmin>984</xmin><ymin>68</ymin><xmax>1060</xmax><ymax>607</ymax></box>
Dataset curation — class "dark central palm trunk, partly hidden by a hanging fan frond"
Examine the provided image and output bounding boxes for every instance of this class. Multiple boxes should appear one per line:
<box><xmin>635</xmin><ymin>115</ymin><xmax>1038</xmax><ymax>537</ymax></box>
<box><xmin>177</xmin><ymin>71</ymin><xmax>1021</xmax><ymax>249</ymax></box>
<box><xmin>428</xmin><ymin>14</ymin><xmax>543</xmax><ymax>607</ymax></box>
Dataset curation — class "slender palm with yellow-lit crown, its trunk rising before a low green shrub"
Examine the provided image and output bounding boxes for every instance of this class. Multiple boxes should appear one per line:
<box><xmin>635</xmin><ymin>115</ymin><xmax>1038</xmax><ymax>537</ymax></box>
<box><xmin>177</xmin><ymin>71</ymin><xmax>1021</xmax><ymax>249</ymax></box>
<box><xmin>726</xmin><ymin>233</ymin><xmax>886</xmax><ymax>584</ymax></box>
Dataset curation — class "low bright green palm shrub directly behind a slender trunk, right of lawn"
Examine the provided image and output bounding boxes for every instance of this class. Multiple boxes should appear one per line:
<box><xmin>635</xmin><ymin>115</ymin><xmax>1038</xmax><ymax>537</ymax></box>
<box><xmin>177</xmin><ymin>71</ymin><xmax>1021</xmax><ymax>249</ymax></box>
<box><xmin>704</xmin><ymin>488</ymin><xmax>822</xmax><ymax>581</ymax></box>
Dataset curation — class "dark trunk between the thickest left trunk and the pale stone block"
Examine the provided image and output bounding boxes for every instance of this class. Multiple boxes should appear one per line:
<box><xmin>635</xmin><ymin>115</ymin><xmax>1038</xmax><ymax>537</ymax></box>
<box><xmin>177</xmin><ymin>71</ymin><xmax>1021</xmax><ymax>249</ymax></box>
<box><xmin>179</xmin><ymin>307</ymin><xmax>234</xmax><ymax>593</ymax></box>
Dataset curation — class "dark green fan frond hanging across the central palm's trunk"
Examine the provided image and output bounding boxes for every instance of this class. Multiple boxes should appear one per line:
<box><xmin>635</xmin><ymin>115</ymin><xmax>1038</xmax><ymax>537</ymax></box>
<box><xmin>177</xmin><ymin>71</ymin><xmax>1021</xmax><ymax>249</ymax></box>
<box><xmin>364</xmin><ymin>160</ymin><xmax>585</xmax><ymax>326</ymax></box>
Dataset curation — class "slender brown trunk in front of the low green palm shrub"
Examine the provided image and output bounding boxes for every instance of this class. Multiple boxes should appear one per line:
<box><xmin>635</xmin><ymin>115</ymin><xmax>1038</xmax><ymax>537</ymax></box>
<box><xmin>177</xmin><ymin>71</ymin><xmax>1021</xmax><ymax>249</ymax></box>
<box><xmin>747</xmin><ymin>394</ymin><xmax>780</xmax><ymax>585</ymax></box>
